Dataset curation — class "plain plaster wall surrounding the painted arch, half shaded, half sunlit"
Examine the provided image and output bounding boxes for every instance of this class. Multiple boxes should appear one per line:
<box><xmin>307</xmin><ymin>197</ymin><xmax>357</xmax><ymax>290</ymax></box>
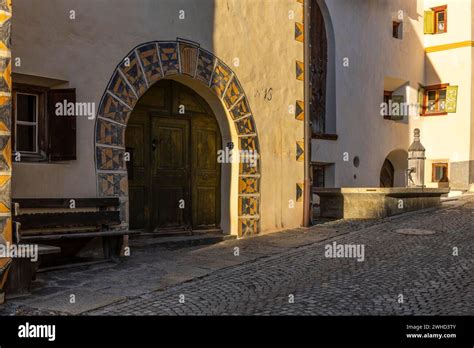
<box><xmin>13</xmin><ymin>0</ymin><xmax>303</xmax><ymax>231</ymax></box>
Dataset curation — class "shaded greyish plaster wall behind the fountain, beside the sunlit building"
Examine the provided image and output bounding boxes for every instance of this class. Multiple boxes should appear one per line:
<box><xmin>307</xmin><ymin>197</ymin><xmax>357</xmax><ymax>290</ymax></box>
<box><xmin>312</xmin><ymin>0</ymin><xmax>424</xmax><ymax>187</ymax></box>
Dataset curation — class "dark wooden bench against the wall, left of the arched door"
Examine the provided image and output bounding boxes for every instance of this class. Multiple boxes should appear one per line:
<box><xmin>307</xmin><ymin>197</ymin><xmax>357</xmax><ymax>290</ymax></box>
<box><xmin>6</xmin><ymin>198</ymin><xmax>138</xmax><ymax>295</ymax></box>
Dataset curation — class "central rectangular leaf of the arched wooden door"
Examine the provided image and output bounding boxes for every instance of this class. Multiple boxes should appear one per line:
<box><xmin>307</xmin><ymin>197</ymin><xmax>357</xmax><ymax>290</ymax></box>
<box><xmin>151</xmin><ymin>117</ymin><xmax>191</xmax><ymax>231</ymax></box>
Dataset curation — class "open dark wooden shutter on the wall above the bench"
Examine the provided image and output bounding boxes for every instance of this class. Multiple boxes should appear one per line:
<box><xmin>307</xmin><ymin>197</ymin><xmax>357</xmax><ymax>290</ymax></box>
<box><xmin>48</xmin><ymin>88</ymin><xmax>76</xmax><ymax>161</ymax></box>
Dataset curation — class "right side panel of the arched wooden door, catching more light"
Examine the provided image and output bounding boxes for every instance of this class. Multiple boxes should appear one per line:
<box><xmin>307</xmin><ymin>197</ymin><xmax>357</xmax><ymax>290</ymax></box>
<box><xmin>191</xmin><ymin>114</ymin><xmax>221</xmax><ymax>229</ymax></box>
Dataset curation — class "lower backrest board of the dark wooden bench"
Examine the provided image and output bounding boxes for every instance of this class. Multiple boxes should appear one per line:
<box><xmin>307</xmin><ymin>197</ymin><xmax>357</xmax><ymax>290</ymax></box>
<box><xmin>14</xmin><ymin>211</ymin><xmax>120</xmax><ymax>230</ymax></box>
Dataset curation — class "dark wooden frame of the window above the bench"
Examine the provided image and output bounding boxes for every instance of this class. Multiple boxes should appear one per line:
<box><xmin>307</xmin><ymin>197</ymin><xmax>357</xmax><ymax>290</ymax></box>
<box><xmin>12</xmin><ymin>83</ymin><xmax>48</xmax><ymax>162</ymax></box>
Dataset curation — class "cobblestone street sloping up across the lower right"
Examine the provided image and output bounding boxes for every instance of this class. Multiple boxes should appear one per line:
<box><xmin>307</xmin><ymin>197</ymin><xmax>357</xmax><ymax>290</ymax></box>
<box><xmin>87</xmin><ymin>198</ymin><xmax>474</xmax><ymax>315</ymax></box>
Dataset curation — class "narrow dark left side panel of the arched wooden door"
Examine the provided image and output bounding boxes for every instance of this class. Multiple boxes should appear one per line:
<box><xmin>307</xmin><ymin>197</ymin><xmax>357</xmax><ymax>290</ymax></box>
<box><xmin>125</xmin><ymin>110</ymin><xmax>150</xmax><ymax>230</ymax></box>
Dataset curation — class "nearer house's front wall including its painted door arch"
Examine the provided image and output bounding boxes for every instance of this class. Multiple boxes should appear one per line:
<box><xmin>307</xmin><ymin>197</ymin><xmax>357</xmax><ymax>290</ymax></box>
<box><xmin>12</xmin><ymin>0</ymin><xmax>304</xmax><ymax>236</ymax></box>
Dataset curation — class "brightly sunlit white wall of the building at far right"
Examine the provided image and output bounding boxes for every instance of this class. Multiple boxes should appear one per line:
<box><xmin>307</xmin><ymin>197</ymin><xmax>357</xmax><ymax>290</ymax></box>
<box><xmin>411</xmin><ymin>0</ymin><xmax>474</xmax><ymax>187</ymax></box>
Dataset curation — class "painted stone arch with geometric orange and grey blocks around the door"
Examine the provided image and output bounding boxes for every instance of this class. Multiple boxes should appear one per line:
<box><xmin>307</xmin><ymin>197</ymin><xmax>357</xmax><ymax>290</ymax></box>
<box><xmin>95</xmin><ymin>40</ymin><xmax>261</xmax><ymax>236</ymax></box>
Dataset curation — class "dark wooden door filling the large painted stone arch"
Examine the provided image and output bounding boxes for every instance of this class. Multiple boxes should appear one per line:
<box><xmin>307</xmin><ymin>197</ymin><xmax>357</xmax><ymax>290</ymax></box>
<box><xmin>125</xmin><ymin>80</ymin><xmax>222</xmax><ymax>232</ymax></box>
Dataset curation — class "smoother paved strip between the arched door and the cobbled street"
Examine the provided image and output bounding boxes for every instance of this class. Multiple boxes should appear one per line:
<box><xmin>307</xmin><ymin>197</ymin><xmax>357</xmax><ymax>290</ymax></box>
<box><xmin>0</xmin><ymin>216</ymin><xmax>344</xmax><ymax>316</ymax></box>
